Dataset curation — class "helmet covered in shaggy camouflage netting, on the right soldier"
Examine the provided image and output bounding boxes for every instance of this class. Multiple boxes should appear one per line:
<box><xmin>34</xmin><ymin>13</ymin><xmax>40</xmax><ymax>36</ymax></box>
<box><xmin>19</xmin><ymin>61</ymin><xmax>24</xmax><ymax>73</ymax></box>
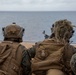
<box><xmin>52</xmin><ymin>19</ymin><xmax>74</xmax><ymax>42</ymax></box>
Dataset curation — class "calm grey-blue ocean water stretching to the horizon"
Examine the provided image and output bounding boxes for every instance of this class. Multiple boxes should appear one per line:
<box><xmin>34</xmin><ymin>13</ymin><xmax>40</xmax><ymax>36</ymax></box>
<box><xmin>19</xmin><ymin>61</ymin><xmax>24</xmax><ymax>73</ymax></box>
<box><xmin>0</xmin><ymin>11</ymin><xmax>76</xmax><ymax>43</ymax></box>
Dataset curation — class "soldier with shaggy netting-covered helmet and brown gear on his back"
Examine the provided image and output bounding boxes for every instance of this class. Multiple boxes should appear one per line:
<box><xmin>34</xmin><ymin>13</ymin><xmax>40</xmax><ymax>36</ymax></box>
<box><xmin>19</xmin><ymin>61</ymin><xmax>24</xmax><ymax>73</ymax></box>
<box><xmin>32</xmin><ymin>19</ymin><xmax>76</xmax><ymax>75</ymax></box>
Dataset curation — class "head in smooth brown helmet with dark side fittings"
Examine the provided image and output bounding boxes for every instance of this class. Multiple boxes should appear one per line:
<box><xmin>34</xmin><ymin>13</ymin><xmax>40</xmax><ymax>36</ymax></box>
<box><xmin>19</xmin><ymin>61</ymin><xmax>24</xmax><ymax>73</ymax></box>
<box><xmin>2</xmin><ymin>22</ymin><xmax>24</xmax><ymax>42</ymax></box>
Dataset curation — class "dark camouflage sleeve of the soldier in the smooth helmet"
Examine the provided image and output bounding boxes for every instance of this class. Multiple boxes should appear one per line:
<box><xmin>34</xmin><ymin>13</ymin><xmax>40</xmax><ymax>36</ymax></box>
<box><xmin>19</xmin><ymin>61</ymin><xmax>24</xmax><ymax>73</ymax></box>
<box><xmin>21</xmin><ymin>47</ymin><xmax>31</xmax><ymax>75</ymax></box>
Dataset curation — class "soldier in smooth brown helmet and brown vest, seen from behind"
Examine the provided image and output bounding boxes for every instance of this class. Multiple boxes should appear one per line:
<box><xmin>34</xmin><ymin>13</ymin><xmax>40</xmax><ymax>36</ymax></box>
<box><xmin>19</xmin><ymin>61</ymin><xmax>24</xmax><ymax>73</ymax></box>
<box><xmin>0</xmin><ymin>22</ymin><xmax>35</xmax><ymax>75</ymax></box>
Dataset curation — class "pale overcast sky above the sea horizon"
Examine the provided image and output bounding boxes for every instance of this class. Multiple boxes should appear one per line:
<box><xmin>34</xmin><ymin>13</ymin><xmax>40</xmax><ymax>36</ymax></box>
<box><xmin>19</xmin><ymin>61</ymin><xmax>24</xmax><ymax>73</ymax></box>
<box><xmin>0</xmin><ymin>0</ymin><xmax>76</xmax><ymax>11</ymax></box>
